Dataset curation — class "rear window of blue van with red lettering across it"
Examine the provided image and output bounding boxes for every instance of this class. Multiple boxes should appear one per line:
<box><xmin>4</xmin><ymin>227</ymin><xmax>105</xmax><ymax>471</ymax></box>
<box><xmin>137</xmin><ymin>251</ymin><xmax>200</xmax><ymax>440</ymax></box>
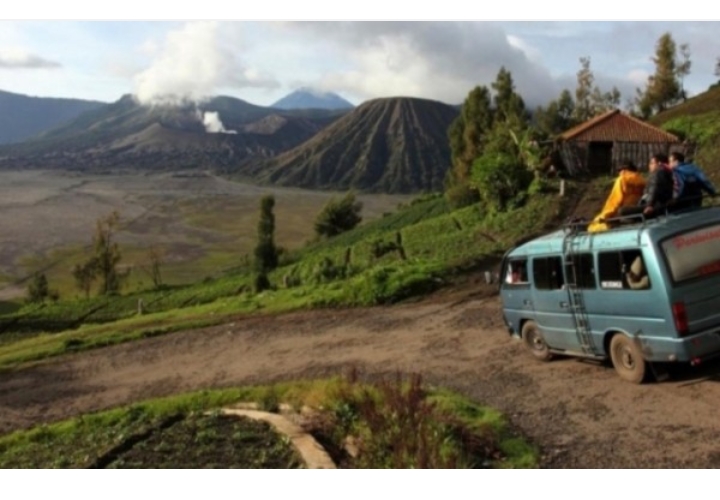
<box><xmin>661</xmin><ymin>224</ymin><xmax>720</xmax><ymax>283</ymax></box>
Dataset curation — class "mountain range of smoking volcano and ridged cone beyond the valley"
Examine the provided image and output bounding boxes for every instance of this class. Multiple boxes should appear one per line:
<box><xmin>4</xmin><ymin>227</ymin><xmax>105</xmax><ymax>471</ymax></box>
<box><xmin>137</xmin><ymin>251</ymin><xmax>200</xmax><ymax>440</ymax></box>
<box><xmin>0</xmin><ymin>89</ymin><xmax>458</xmax><ymax>193</ymax></box>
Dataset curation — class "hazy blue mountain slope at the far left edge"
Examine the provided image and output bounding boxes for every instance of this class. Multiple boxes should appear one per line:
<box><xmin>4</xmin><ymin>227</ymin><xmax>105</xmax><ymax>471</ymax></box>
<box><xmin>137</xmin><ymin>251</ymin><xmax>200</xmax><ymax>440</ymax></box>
<box><xmin>0</xmin><ymin>90</ymin><xmax>105</xmax><ymax>144</ymax></box>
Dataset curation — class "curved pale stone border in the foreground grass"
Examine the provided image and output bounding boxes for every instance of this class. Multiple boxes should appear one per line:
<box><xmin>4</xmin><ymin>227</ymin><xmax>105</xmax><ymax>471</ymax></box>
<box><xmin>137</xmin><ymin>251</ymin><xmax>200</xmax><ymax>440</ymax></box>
<box><xmin>221</xmin><ymin>408</ymin><xmax>337</xmax><ymax>469</ymax></box>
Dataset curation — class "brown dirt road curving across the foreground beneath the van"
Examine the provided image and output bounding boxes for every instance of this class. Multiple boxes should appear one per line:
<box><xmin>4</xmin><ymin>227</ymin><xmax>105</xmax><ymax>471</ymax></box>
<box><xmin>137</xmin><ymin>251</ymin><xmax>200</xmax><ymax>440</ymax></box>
<box><xmin>0</xmin><ymin>286</ymin><xmax>720</xmax><ymax>468</ymax></box>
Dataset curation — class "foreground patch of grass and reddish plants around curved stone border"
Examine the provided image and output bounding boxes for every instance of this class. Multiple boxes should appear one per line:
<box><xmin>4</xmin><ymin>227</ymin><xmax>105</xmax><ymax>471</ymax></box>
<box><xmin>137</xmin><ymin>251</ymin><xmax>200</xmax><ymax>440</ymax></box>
<box><xmin>0</xmin><ymin>375</ymin><xmax>538</xmax><ymax>468</ymax></box>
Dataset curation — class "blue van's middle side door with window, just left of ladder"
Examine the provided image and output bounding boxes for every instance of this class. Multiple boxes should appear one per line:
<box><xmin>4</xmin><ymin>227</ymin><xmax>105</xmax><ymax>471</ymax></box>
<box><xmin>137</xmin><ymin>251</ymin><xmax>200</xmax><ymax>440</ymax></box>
<box><xmin>532</xmin><ymin>255</ymin><xmax>577</xmax><ymax>350</ymax></box>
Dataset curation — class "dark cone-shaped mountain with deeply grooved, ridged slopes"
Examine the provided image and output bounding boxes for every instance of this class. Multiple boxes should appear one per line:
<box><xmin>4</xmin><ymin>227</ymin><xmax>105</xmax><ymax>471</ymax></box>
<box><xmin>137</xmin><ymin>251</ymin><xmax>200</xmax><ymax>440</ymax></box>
<box><xmin>244</xmin><ymin>97</ymin><xmax>458</xmax><ymax>193</ymax></box>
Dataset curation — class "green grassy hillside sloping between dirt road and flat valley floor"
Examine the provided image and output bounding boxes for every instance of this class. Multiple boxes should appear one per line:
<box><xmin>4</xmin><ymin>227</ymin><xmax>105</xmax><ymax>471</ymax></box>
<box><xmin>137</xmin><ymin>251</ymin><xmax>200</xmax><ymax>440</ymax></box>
<box><xmin>0</xmin><ymin>176</ymin><xmax>585</xmax><ymax>367</ymax></box>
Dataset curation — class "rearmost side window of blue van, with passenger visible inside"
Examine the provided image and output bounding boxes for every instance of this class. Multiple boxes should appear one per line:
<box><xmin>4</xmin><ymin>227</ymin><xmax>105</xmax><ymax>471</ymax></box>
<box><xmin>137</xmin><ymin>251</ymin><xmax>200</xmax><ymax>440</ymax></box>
<box><xmin>598</xmin><ymin>250</ymin><xmax>650</xmax><ymax>290</ymax></box>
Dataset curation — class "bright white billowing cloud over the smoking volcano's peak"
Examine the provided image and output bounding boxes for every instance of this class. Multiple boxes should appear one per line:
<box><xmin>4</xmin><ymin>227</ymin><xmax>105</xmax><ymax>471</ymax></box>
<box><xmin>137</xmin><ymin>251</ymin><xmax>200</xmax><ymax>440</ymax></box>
<box><xmin>135</xmin><ymin>22</ymin><xmax>279</xmax><ymax>104</ymax></box>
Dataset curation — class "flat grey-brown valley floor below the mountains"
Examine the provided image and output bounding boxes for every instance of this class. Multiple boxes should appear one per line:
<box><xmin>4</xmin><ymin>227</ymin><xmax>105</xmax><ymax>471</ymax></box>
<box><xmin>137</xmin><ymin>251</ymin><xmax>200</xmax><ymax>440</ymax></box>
<box><xmin>0</xmin><ymin>170</ymin><xmax>412</xmax><ymax>300</ymax></box>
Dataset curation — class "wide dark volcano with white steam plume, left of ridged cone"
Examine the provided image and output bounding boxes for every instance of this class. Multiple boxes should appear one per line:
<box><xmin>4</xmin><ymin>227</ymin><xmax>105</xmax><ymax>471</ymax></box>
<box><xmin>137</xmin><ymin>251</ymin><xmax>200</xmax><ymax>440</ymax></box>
<box><xmin>0</xmin><ymin>95</ymin><xmax>342</xmax><ymax>170</ymax></box>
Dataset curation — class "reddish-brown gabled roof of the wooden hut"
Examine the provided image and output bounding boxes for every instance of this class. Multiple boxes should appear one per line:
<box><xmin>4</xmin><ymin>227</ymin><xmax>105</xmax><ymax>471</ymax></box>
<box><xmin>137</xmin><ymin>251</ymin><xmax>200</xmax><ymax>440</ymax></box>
<box><xmin>560</xmin><ymin>109</ymin><xmax>680</xmax><ymax>142</ymax></box>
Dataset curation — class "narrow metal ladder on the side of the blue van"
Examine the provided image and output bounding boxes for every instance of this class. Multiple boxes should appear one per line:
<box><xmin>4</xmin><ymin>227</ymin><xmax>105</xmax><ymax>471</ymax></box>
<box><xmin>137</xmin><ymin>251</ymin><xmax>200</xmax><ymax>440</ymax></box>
<box><xmin>563</xmin><ymin>225</ymin><xmax>597</xmax><ymax>355</ymax></box>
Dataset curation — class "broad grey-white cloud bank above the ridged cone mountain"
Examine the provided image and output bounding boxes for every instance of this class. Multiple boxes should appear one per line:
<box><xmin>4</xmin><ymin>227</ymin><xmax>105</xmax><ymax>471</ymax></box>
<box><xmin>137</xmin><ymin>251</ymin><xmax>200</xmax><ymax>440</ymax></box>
<box><xmin>268</xmin><ymin>22</ymin><xmax>559</xmax><ymax>107</ymax></box>
